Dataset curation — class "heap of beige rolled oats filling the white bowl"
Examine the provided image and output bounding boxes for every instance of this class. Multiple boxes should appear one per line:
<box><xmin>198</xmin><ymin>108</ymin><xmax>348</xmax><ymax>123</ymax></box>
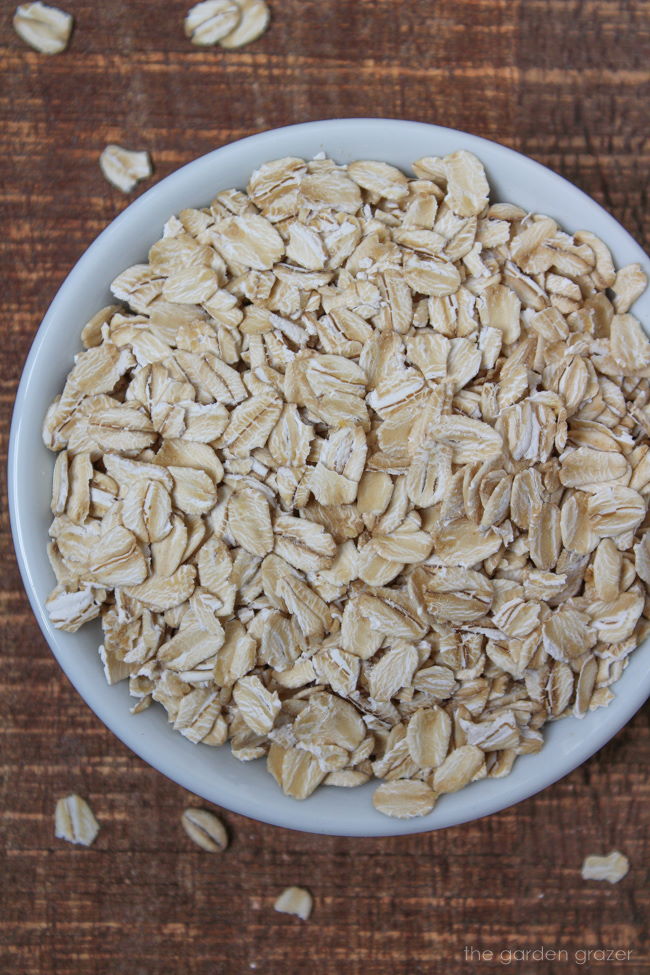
<box><xmin>44</xmin><ymin>151</ymin><xmax>650</xmax><ymax>816</ymax></box>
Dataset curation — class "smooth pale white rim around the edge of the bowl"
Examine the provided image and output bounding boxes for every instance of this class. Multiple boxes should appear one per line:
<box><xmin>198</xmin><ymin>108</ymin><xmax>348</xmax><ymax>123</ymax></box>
<box><xmin>7</xmin><ymin>117</ymin><xmax>650</xmax><ymax>836</ymax></box>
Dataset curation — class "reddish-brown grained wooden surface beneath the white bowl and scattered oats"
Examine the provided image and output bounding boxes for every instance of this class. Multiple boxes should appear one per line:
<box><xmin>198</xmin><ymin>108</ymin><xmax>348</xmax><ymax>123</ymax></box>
<box><xmin>0</xmin><ymin>0</ymin><xmax>650</xmax><ymax>975</ymax></box>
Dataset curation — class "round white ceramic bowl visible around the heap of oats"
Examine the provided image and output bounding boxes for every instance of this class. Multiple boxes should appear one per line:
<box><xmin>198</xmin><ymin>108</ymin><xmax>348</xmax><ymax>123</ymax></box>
<box><xmin>9</xmin><ymin>119</ymin><xmax>650</xmax><ymax>836</ymax></box>
